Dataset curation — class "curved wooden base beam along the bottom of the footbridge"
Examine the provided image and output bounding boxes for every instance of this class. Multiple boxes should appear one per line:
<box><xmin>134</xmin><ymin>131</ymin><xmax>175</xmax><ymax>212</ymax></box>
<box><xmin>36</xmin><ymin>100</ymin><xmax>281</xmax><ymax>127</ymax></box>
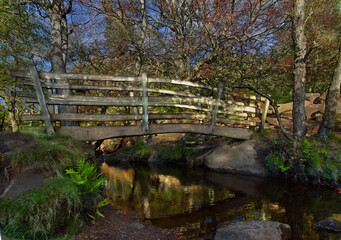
<box><xmin>56</xmin><ymin>124</ymin><xmax>252</xmax><ymax>141</ymax></box>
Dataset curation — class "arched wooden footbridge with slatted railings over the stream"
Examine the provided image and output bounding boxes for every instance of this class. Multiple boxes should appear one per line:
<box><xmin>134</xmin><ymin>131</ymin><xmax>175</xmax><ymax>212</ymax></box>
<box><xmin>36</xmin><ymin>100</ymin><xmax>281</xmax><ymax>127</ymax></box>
<box><xmin>11</xmin><ymin>67</ymin><xmax>268</xmax><ymax>140</ymax></box>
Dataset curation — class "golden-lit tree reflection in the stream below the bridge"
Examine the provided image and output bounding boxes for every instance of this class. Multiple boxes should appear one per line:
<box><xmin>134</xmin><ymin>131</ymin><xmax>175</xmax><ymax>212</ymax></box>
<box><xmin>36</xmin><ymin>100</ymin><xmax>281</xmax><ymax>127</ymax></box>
<box><xmin>102</xmin><ymin>163</ymin><xmax>235</xmax><ymax>218</ymax></box>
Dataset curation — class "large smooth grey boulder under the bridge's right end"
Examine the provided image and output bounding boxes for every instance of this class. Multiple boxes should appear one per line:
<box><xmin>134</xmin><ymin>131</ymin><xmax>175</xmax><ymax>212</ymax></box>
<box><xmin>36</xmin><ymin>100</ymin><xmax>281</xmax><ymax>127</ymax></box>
<box><xmin>203</xmin><ymin>140</ymin><xmax>267</xmax><ymax>176</ymax></box>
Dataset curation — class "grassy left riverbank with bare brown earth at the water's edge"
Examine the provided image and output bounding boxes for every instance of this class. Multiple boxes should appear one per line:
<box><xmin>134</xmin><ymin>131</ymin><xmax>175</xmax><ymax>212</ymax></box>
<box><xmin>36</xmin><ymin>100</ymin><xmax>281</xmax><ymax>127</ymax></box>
<box><xmin>0</xmin><ymin>132</ymin><xmax>181</xmax><ymax>240</ymax></box>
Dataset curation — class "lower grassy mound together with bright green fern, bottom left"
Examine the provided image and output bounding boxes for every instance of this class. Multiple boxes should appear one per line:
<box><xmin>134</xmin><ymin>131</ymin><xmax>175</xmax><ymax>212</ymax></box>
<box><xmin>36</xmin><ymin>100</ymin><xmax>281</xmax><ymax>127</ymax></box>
<box><xmin>0</xmin><ymin>158</ymin><xmax>108</xmax><ymax>239</ymax></box>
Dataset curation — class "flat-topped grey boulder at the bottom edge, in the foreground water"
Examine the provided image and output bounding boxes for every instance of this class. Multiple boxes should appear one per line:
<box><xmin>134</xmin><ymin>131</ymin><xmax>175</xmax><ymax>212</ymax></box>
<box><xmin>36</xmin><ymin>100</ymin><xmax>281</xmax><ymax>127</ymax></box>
<box><xmin>214</xmin><ymin>221</ymin><xmax>291</xmax><ymax>240</ymax></box>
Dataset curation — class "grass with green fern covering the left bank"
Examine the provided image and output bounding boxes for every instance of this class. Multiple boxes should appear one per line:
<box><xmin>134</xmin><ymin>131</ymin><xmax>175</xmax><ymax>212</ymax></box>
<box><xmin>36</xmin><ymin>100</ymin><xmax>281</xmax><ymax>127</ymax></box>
<box><xmin>0</xmin><ymin>130</ymin><xmax>107</xmax><ymax>239</ymax></box>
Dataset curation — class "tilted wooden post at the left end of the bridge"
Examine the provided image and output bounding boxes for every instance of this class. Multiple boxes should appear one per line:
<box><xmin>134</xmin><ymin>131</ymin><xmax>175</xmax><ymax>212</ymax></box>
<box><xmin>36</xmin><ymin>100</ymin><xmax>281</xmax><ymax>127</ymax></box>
<box><xmin>30</xmin><ymin>66</ymin><xmax>55</xmax><ymax>136</ymax></box>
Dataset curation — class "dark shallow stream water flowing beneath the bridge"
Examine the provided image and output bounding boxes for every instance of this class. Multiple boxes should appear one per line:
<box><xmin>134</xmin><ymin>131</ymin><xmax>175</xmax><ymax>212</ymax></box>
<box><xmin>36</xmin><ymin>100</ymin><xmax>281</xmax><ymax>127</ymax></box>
<box><xmin>103</xmin><ymin>163</ymin><xmax>341</xmax><ymax>240</ymax></box>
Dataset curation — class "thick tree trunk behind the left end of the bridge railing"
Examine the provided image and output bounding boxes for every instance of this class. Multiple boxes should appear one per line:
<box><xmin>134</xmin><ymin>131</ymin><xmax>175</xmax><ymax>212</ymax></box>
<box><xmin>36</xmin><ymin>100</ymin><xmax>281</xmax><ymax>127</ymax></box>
<box><xmin>48</xmin><ymin>0</ymin><xmax>78</xmax><ymax>126</ymax></box>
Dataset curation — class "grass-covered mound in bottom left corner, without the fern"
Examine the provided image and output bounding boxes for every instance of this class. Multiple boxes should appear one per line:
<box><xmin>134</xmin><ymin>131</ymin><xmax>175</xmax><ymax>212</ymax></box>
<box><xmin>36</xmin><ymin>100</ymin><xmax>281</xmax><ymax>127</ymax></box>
<box><xmin>0</xmin><ymin>177</ymin><xmax>82</xmax><ymax>239</ymax></box>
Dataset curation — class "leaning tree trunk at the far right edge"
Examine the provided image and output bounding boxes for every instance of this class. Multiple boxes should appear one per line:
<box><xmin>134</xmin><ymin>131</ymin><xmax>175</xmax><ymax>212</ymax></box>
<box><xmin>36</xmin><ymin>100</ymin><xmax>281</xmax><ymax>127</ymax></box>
<box><xmin>318</xmin><ymin>45</ymin><xmax>341</xmax><ymax>141</ymax></box>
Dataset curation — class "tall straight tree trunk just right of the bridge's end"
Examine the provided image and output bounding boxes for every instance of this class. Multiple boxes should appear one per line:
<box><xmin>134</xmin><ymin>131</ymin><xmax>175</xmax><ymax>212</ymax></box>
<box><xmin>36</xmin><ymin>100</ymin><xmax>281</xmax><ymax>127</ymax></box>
<box><xmin>292</xmin><ymin>0</ymin><xmax>307</xmax><ymax>146</ymax></box>
